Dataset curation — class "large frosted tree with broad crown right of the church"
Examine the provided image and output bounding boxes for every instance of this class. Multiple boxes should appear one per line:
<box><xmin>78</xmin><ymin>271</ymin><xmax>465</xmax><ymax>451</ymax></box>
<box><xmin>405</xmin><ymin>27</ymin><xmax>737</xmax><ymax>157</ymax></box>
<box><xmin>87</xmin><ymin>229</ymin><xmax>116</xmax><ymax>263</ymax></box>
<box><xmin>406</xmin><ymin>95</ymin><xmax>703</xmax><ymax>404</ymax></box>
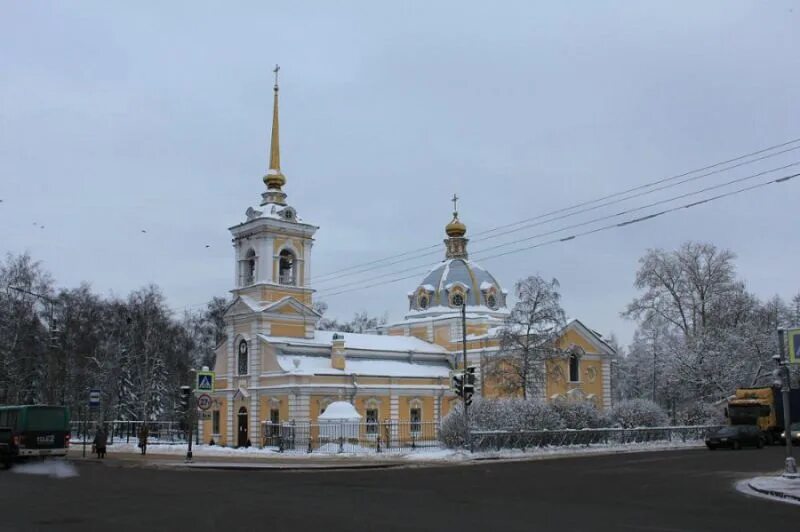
<box><xmin>622</xmin><ymin>242</ymin><xmax>790</xmax><ymax>410</ymax></box>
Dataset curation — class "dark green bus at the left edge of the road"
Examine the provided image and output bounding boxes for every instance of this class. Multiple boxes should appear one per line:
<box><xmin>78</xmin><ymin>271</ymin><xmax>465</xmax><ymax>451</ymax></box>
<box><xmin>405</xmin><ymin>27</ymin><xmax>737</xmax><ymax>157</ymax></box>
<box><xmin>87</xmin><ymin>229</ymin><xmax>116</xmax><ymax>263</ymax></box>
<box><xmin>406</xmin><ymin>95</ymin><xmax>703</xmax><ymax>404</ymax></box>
<box><xmin>0</xmin><ymin>405</ymin><xmax>70</xmax><ymax>459</ymax></box>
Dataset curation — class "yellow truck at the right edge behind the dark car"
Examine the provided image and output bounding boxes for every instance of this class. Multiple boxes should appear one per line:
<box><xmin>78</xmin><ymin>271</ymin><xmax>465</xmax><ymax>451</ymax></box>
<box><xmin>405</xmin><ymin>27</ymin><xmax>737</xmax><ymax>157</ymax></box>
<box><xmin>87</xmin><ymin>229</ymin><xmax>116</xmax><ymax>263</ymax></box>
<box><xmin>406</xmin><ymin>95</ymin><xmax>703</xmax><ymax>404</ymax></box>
<box><xmin>725</xmin><ymin>386</ymin><xmax>800</xmax><ymax>445</ymax></box>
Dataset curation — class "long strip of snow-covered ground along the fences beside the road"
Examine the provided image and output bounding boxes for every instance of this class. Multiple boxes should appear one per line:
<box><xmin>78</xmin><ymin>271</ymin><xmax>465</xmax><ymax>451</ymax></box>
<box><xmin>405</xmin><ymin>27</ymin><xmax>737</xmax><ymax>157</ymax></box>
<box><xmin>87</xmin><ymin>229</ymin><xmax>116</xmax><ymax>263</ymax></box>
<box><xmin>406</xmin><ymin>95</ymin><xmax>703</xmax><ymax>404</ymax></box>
<box><xmin>95</xmin><ymin>441</ymin><xmax>703</xmax><ymax>462</ymax></box>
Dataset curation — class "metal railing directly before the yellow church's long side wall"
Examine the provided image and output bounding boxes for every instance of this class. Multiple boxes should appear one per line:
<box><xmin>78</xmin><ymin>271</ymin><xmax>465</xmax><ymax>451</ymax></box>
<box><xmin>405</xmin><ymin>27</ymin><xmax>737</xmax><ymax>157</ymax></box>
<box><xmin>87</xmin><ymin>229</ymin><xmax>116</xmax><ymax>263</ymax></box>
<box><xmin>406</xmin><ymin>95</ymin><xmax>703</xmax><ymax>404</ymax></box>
<box><xmin>262</xmin><ymin>421</ymin><xmax>441</xmax><ymax>454</ymax></box>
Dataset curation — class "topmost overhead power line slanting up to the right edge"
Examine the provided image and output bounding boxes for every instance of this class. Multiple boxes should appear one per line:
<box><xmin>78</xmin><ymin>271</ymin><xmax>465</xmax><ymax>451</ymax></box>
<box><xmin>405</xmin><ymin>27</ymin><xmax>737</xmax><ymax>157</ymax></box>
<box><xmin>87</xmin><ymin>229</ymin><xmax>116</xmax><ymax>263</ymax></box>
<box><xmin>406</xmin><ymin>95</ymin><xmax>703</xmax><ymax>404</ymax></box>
<box><xmin>316</xmin><ymin>138</ymin><xmax>800</xmax><ymax>282</ymax></box>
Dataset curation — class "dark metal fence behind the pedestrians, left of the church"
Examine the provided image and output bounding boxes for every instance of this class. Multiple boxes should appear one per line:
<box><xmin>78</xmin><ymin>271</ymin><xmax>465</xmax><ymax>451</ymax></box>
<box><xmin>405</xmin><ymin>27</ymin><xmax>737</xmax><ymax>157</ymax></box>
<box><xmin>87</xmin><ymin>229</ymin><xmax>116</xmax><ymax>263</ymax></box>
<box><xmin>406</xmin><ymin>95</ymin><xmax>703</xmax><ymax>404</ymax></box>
<box><xmin>70</xmin><ymin>421</ymin><xmax>192</xmax><ymax>445</ymax></box>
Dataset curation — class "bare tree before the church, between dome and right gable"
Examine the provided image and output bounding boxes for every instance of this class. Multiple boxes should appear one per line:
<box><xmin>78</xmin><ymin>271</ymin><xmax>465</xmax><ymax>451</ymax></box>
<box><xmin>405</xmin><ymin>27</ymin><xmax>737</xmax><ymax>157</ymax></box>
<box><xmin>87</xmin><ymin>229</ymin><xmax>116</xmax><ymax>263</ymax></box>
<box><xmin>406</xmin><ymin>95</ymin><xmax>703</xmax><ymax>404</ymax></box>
<box><xmin>485</xmin><ymin>275</ymin><xmax>566</xmax><ymax>399</ymax></box>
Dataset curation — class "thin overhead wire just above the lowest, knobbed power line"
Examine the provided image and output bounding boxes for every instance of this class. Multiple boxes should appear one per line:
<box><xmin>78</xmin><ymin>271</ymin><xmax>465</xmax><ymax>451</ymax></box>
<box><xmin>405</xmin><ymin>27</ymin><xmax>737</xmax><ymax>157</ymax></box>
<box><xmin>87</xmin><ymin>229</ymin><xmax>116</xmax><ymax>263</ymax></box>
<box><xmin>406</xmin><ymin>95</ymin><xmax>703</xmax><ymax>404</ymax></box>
<box><xmin>312</xmin><ymin>161</ymin><xmax>800</xmax><ymax>295</ymax></box>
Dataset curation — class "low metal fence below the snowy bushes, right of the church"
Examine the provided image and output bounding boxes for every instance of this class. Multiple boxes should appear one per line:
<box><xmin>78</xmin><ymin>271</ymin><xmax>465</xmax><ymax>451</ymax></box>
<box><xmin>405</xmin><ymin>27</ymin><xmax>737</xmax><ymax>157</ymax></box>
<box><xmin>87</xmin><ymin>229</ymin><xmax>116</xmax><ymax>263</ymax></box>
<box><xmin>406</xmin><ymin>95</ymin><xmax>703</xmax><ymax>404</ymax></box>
<box><xmin>470</xmin><ymin>425</ymin><xmax>721</xmax><ymax>451</ymax></box>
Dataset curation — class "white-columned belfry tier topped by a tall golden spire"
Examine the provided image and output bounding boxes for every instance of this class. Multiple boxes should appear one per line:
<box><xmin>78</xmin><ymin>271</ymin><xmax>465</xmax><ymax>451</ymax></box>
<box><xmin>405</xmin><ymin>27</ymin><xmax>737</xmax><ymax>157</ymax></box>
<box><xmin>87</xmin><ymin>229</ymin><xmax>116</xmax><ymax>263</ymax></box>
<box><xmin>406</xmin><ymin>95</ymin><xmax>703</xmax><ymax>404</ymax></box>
<box><xmin>230</xmin><ymin>65</ymin><xmax>318</xmax><ymax>307</ymax></box>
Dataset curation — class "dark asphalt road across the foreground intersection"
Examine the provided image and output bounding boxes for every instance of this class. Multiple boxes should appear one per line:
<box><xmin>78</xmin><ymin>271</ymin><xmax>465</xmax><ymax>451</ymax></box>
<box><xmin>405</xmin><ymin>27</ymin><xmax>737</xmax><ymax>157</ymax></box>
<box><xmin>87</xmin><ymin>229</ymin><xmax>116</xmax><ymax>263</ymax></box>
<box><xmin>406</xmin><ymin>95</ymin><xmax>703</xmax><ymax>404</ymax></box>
<box><xmin>0</xmin><ymin>448</ymin><xmax>800</xmax><ymax>532</ymax></box>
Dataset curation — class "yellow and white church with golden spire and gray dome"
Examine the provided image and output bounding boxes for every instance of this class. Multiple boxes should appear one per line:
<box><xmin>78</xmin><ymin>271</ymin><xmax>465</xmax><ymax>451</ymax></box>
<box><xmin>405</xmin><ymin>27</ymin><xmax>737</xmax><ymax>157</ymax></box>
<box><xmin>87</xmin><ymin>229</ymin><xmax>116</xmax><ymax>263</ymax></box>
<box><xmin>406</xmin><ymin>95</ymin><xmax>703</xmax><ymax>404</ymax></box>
<box><xmin>199</xmin><ymin>72</ymin><xmax>613</xmax><ymax>446</ymax></box>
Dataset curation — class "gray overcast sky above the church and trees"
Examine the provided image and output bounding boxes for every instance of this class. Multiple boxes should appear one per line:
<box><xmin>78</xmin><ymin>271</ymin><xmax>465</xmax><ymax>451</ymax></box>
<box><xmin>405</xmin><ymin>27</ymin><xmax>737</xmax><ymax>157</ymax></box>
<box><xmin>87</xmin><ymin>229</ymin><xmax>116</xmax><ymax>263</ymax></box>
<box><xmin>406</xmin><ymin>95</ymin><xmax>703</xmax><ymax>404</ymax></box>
<box><xmin>0</xmin><ymin>0</ymin><xmax>800</xmax><ymax>342</ymax></box>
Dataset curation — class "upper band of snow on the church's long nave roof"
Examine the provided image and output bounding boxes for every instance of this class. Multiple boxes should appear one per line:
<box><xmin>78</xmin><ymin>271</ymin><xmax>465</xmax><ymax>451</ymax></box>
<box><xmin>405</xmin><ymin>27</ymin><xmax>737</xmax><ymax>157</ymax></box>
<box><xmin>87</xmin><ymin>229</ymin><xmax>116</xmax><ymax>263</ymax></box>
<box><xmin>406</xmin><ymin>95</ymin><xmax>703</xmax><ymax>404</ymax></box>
<box><xmin>266</xmin><ymin>331</ymin><xmax>447</xmax><ymax>353</ymax></box>
